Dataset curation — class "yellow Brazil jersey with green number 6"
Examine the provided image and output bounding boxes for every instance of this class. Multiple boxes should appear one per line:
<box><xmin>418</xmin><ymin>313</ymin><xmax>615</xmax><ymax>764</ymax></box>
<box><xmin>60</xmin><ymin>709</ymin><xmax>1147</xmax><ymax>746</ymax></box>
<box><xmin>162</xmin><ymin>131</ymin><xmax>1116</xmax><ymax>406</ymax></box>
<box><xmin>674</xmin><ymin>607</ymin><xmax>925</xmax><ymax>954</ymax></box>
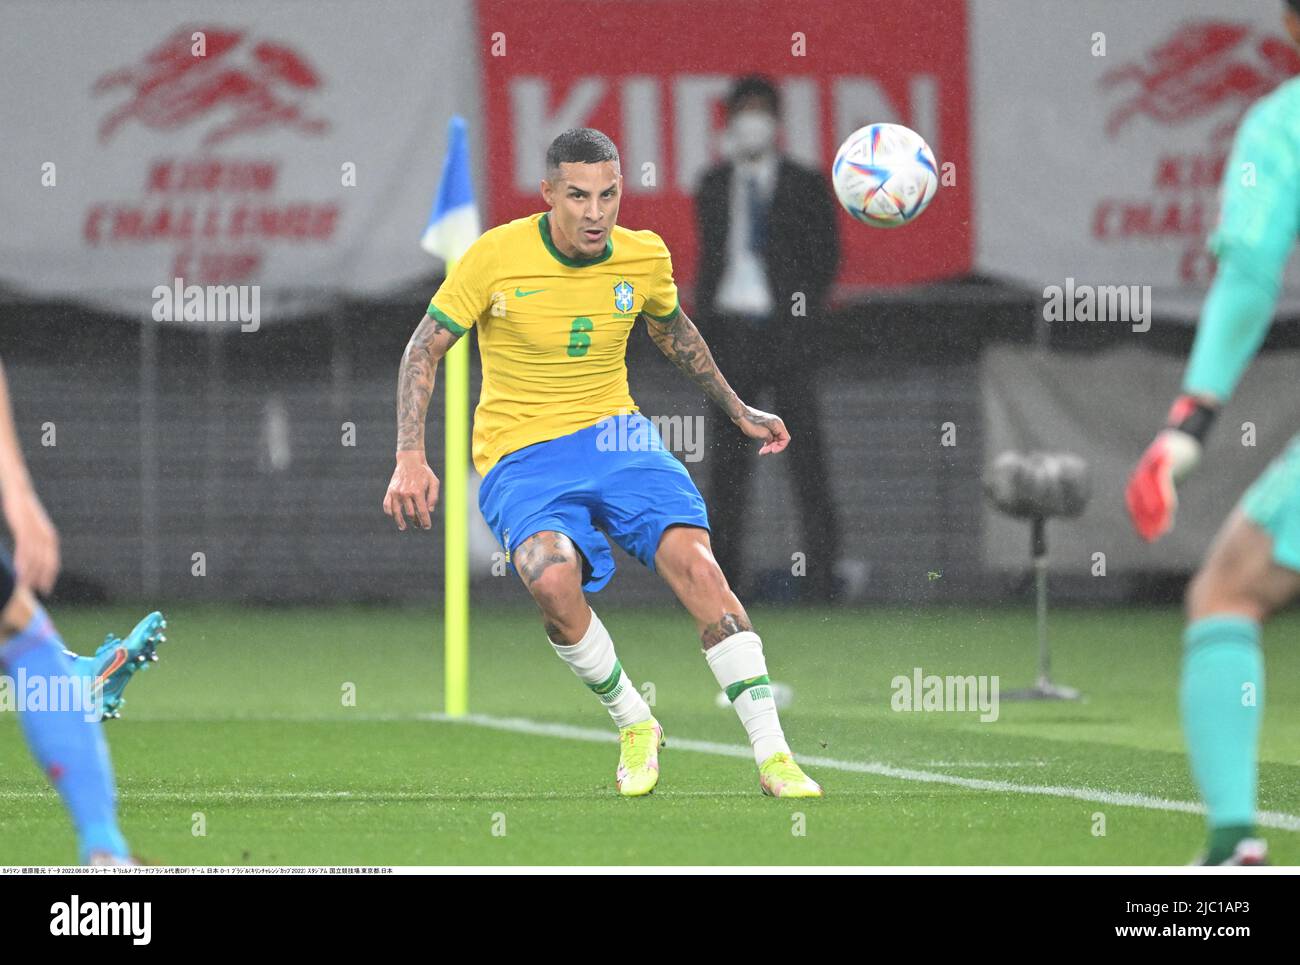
<box><xmin>429</xmin><ymin>213</ymin><xmax>677</xmax><ymax>475</ymax></box>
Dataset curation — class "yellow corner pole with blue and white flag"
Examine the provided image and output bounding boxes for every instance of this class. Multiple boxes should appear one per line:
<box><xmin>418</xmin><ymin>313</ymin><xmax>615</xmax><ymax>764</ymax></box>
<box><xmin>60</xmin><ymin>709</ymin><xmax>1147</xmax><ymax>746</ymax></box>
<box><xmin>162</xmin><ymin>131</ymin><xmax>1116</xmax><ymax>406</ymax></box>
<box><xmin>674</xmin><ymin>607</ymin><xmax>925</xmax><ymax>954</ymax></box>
<box><xmin>420</xmin><ymin>114</ymin><xmax>480</xmax><ymax>717</ymax></box>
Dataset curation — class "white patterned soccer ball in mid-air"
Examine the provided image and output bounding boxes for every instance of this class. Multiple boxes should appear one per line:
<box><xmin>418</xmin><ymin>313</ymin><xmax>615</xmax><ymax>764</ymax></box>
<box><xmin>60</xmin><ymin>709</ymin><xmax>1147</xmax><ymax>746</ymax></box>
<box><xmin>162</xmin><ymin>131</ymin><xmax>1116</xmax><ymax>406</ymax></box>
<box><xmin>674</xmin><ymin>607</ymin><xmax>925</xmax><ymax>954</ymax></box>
<box><xmin>831</xmin><ymin>124</ymin><xmax>939</xmax><ymax>228</ymax></box>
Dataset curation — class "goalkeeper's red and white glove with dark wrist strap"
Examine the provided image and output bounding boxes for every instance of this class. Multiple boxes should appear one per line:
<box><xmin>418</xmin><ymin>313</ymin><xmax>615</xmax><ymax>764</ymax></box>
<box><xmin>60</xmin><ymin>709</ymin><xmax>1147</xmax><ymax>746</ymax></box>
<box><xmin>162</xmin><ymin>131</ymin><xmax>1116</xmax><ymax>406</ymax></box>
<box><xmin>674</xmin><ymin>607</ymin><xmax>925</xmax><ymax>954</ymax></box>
<box><xmin>1125</xmin><ymin>395</ymin><xmax>1216</xmax><ymax>542</ymax></box>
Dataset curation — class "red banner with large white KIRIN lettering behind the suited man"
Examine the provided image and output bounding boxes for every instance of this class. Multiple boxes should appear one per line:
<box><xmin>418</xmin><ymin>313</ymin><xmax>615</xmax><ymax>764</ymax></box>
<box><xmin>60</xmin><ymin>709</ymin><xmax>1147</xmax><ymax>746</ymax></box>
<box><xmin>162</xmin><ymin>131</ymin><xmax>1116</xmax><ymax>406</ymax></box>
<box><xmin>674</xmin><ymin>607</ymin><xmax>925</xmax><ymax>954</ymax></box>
<box><xmin>478</xmin><ymin>0</ymin><xmax>971</xmax><ymax>304</ymax></box>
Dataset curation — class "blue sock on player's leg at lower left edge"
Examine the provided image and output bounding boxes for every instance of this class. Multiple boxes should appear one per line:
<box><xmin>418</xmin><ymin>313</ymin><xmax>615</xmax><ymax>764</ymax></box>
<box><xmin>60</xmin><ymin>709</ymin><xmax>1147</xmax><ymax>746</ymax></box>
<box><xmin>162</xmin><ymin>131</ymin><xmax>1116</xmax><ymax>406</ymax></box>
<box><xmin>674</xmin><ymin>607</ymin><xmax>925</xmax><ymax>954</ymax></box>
<box><xmin>0</xmin><ymin>609</ymin><xmax>129</xmax><ymax>862</ymax></box>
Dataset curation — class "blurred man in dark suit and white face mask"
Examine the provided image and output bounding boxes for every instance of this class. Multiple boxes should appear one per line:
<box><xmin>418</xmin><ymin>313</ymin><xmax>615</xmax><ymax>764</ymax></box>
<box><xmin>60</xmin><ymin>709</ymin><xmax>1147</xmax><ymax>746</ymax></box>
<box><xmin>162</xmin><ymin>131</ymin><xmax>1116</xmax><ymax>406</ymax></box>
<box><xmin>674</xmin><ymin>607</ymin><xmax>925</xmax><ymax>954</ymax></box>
<box><xmin>696</xmin><ymin>75</ymin><xmax>840</xmax><ymax>601</ymax></box>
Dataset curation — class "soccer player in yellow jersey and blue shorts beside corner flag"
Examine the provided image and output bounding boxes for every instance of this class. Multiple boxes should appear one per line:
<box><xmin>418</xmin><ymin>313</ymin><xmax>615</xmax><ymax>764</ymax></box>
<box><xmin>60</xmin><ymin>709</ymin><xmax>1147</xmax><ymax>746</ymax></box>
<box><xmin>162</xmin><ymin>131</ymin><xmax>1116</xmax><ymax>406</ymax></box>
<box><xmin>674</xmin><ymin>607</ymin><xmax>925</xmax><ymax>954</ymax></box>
<box><xmin>384</xmin><ymin>127</ymin><xmax>822</xmax><ymax>797</ymax></box>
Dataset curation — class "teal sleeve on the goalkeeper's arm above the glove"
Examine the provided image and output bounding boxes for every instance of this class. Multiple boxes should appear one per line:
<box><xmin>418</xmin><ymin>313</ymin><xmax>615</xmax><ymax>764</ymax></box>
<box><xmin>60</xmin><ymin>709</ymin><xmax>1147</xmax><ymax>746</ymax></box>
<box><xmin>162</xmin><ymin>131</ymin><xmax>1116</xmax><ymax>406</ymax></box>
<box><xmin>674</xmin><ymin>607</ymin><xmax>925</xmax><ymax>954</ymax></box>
<box><xmin>1183</xmin><ymin>78</ymin><xmax>1300</xmax><ymax>402</ymax></box>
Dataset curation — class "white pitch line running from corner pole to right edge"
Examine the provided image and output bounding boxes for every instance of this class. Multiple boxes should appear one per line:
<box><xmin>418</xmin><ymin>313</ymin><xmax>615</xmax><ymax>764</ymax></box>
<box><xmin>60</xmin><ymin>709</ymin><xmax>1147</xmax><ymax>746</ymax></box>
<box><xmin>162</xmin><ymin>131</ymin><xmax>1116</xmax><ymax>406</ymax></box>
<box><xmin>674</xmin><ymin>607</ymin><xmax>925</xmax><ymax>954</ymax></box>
<box><xmin>423</xmin><ymin>714</ymin><xmax>1300</xmax><ymax>831</ymax></box>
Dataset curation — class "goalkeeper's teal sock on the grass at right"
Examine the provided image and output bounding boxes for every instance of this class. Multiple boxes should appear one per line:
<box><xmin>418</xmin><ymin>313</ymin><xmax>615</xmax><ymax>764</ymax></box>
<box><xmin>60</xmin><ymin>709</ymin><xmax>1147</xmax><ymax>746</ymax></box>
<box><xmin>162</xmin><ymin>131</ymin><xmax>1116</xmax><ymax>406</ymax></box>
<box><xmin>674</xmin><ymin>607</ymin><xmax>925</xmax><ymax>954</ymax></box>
<box><xmin>1179</xmin><ymin>615</ymin><xmax>1264</xmax><ymax>864</ymax></box>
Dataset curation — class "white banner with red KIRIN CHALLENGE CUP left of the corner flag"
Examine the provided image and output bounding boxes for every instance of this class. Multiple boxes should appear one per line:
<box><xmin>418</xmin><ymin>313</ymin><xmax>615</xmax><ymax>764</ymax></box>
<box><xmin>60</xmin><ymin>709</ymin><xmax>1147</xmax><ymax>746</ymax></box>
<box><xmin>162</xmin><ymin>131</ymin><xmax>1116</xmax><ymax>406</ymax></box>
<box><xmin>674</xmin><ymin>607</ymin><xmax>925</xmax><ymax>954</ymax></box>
<box><xmin>0</xmin><ymin>0</ymin><xmax>478</xmax><ymax>325</ymax></box>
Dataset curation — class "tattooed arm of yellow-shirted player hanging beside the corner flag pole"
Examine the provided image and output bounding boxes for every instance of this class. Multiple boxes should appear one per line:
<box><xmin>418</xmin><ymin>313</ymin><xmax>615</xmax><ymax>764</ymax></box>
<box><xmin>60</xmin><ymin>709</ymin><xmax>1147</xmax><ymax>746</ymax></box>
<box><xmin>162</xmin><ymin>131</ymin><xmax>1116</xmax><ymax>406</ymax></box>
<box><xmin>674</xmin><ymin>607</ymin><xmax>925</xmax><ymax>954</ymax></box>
<box><xmin>384</xmin><ymin>315</ymin><xmax>460</xmax><ymax>529</ymax></box>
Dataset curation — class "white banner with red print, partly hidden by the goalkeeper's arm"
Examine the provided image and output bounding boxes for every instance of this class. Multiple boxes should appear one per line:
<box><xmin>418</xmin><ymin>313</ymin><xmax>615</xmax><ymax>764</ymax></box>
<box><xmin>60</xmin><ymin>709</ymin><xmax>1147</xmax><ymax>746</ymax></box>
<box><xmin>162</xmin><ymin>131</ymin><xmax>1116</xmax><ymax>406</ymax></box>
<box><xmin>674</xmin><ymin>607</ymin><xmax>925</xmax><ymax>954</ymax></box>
<box><xmin>970</xmin><ymin>0</ymin><xmax>1300</xmax><ymax>315</ymax></box>
